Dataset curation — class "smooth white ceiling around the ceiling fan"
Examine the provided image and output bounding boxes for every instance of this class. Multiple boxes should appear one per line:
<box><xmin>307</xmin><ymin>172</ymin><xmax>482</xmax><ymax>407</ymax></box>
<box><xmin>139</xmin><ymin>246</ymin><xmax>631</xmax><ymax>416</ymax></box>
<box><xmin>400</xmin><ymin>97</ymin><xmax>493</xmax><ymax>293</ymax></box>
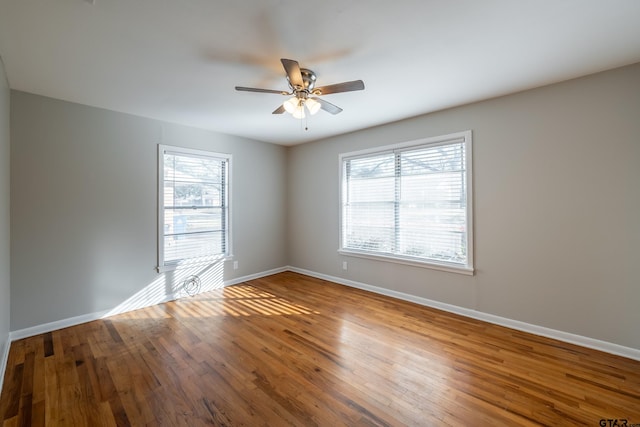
<box><xmin>0</xmin><ymin>0</ymin><xmax>640</xmax><ymax>145</ymax></box>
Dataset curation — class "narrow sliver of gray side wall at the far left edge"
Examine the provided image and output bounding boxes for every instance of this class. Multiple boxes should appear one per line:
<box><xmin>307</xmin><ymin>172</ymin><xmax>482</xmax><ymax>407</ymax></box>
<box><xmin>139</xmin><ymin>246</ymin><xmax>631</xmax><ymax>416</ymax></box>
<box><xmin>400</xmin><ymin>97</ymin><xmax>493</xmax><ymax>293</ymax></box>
<box><xmin>0</xmin><ymin>58</ymin><xmax>11</xmax><ymax>364</ymax></box>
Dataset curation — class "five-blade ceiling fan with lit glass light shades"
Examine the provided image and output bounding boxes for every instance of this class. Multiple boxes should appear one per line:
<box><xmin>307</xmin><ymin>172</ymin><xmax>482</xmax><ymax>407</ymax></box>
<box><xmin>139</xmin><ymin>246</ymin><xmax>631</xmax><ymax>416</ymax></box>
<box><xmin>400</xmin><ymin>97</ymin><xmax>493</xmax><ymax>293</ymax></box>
<box><xmin>236</xmin><ymin>58</ymin><xmax>364</xmax><ymax>119</ymax></box>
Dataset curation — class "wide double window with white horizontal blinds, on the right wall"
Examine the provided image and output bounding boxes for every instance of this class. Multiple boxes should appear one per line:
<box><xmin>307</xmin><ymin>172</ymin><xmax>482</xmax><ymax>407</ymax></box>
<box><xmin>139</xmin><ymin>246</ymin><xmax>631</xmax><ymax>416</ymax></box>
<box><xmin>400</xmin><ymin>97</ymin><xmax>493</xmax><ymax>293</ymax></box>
<box><xmin>340</xmin><ymin>131</ymin><xmax>473</xmax><ymax>274</ymax></box>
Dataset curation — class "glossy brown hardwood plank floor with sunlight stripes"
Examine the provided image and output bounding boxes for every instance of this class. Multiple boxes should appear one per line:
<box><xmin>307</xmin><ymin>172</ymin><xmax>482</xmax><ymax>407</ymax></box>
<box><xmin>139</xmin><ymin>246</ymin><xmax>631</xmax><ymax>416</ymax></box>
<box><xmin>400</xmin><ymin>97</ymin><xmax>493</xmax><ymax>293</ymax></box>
<box><xmin>0</xmin><ymin>272</ymin><xmax>640</xmax><ymax>427</ymax></box>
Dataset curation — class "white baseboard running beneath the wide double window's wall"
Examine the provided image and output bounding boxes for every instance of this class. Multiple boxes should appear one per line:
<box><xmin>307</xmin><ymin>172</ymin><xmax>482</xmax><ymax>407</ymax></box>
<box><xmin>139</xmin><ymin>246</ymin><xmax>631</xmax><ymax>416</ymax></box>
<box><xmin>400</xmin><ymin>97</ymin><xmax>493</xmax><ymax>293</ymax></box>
<box><xmin>288</xmin><ymin>267</ymin><xmax>640</xmax><ymax>361</ymax></box>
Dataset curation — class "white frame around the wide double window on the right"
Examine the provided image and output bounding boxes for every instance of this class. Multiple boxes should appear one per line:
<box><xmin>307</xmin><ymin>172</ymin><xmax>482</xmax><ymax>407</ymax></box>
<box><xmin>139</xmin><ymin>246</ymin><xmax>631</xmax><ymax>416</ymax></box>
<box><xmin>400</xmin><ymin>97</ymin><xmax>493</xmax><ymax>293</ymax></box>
<box><xmin>338</xmin><ymin>130</ymin><xmax>474</xmax><ymax>275</ymax></box>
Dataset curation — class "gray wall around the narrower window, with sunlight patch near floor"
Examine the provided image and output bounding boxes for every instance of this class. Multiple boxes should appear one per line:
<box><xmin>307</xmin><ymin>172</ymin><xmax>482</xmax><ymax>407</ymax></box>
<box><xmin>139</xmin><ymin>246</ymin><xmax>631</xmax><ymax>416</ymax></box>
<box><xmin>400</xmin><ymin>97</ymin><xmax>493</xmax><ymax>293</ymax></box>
<box><xmin>9</xmin><ymin>91</ymin><xmax>287</xmax><ymax>331</ymax></box>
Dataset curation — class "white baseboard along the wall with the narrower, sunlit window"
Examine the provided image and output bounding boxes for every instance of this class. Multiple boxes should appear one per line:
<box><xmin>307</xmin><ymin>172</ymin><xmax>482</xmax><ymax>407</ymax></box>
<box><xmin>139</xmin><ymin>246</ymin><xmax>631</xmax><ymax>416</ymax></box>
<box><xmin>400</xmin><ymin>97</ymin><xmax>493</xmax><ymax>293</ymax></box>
<box><xmin>9</xmin><ymin>267</ymin><xmax>288</xmax><ymax>344</ymax></box>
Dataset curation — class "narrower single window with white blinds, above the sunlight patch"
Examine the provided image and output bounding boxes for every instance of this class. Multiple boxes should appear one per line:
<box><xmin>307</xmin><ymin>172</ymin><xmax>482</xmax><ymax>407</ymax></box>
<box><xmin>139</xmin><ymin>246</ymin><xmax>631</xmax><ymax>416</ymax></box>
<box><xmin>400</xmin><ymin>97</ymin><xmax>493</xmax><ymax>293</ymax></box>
<box><xmin>158</xmin><ymin>145</ymin><xmax>231</xmax><ymax>271</ymax></box>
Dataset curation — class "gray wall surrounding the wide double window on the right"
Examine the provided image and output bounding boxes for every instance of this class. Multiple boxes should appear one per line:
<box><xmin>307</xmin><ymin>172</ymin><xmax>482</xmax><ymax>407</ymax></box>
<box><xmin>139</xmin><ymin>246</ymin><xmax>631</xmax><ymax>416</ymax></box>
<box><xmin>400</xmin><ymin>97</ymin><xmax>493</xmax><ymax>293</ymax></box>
<box><xmin>288</xmin><ymin>64</ymin><xmax>640</xmax><ymax>349</ymax></box>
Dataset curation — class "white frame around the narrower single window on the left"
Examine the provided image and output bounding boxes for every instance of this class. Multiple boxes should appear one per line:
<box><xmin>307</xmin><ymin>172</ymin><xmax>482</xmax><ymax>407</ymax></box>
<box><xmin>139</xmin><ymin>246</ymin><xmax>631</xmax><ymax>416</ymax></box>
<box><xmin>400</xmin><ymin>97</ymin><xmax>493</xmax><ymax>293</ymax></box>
<box><xmin>156</xmin><ymin>144</ymin><xmax>233</xmax><ymax>273</ymax></box>
